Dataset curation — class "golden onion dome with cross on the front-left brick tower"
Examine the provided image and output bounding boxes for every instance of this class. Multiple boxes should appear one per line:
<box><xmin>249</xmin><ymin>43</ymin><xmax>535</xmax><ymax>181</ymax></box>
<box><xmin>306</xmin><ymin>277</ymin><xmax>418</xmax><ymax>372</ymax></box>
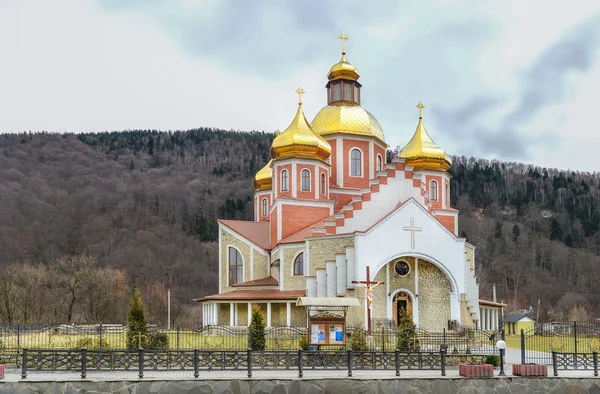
<box><xmin>271</xmin><ymin>88</ymin><xmax>331</xmax><ymax>161</ymax></box>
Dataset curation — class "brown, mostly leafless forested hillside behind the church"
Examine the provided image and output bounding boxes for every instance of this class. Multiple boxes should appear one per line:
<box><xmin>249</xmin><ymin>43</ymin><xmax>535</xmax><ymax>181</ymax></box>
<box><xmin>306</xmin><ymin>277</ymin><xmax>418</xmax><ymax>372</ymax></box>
<box><xmin>0</xmin><ymin>129</ymin><xmax>600</xmax><ymax>326</ymax></box>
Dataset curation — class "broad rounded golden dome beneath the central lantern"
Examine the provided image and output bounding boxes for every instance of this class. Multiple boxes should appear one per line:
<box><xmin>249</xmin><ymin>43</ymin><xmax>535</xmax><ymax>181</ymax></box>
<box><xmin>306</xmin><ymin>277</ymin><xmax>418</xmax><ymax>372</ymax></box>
<box><xmin>312</xmin><ymin>101</ymin><xmax>387</xmax><ymax>146</ymax></box>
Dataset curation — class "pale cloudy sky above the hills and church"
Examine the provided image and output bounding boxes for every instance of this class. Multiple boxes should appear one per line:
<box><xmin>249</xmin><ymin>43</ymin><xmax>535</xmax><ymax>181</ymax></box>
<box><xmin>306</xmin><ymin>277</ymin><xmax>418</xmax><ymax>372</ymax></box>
<box><xmin>0</xmin><ymin>0</ymin><xmax>600</xmax><ymax>171</ymax></box>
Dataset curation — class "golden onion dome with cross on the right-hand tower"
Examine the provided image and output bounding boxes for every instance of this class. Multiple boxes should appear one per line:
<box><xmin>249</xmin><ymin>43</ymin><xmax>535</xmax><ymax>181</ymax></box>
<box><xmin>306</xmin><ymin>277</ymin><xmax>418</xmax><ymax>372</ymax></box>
<box><xmin>400</xmin><ymin>103</ymin><xmax>452</xmax><ymax>171</ymax></box>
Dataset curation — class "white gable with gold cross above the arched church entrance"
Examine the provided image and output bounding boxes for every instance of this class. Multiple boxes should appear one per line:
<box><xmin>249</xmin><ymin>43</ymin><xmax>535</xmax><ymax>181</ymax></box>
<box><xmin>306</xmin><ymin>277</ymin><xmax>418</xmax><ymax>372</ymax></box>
<box><xmin>356</xmin><ymin>199</ymin><xmax>465</xmax><ymax>292</ymax></box>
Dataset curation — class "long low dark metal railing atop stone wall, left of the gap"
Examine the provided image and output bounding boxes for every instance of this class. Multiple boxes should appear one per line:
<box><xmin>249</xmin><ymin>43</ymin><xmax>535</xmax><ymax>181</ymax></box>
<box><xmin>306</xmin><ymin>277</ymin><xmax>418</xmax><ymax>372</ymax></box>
<box><xmin>20</xmin><ymin>348</ymin><xmax>484</xmax><ymax>379</ymax></box>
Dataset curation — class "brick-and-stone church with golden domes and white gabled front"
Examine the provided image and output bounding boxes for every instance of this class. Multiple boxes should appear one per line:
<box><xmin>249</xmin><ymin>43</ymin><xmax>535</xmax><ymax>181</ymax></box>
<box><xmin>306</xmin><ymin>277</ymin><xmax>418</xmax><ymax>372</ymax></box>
<box><xmin>196</xmin><ymin>34</ymin><xmax>504</xmax><ymax>331</ymax></box>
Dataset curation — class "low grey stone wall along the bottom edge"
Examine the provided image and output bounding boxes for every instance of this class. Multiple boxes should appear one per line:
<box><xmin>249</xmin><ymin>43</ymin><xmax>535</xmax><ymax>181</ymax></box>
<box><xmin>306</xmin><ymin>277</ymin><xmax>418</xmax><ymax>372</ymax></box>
<box><xmin>0</xmin><ymin>378</ymin><xmax>600</xmax><ymax>394</ymax></box>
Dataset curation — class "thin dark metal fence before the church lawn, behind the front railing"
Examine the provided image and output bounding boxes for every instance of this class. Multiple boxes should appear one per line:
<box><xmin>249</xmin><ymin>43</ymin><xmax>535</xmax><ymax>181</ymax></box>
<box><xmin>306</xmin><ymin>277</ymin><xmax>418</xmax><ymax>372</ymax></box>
<box><xmin>0</xmin><ymin>324</ymin><xmax>500</xmax><ymax>354</ymax></box>
